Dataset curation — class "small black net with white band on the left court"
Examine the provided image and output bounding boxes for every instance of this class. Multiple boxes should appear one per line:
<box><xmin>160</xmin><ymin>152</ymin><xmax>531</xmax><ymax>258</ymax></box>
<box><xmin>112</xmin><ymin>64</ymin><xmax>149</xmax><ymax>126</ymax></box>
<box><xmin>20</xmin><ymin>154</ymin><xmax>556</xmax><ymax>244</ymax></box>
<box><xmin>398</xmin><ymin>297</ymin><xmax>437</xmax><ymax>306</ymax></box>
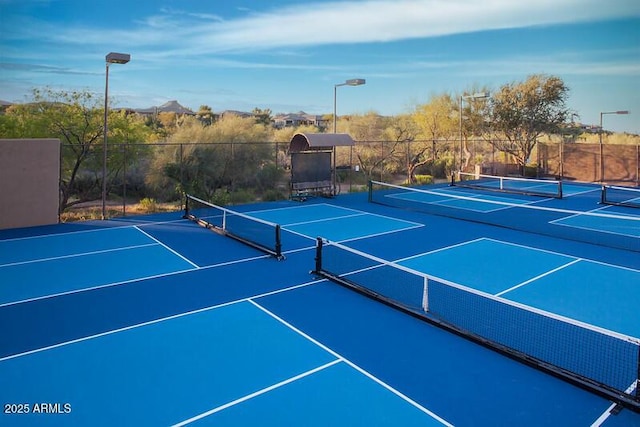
<box><xmin>184</xmin><ymin>194</ymin><xmax>283</xmax><ymax>259</ymax></box>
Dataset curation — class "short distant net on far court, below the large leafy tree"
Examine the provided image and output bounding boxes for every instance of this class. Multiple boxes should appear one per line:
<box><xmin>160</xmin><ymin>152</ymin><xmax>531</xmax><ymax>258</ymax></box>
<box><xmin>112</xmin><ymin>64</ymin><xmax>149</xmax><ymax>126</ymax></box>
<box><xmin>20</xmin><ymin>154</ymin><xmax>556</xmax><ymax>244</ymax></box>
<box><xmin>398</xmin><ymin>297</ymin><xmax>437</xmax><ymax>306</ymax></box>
<box><xmin>451</xmin><ymin>172</ymin><xmax>562</xmax><ymax>199</ymax></box>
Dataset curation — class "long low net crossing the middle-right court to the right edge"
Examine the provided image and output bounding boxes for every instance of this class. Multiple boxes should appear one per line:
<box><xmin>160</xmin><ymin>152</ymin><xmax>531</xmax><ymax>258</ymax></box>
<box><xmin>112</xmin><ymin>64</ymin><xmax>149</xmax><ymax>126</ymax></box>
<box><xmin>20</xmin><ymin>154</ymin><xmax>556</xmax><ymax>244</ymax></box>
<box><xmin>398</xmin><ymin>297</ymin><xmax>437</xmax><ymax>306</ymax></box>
<box><xmin>369</xmin><ymin>181</ymin><xmax>640</xmax><ymax>252</ymax></box>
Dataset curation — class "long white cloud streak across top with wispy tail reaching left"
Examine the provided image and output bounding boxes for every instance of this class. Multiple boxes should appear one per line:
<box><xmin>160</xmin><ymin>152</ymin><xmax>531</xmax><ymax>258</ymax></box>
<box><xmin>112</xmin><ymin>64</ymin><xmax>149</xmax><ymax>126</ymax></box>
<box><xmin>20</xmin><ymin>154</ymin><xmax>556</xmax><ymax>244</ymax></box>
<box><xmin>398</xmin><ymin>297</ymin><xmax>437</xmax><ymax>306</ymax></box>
<box><xmin>10</xmin><ymin>0</ymin><xmax>640</xmax><ymax>57</ymax></box>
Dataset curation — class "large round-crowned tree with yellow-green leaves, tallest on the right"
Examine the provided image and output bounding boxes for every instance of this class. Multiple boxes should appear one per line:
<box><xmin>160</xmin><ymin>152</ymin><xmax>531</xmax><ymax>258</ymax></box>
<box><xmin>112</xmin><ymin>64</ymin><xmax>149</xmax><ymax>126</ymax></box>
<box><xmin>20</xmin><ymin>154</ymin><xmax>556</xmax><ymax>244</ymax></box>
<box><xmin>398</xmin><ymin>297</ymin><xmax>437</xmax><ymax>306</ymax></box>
<box><xmin>487</xmin><ymin>74</ymin><xmax>570</xmax><ymax>174</ymax></box>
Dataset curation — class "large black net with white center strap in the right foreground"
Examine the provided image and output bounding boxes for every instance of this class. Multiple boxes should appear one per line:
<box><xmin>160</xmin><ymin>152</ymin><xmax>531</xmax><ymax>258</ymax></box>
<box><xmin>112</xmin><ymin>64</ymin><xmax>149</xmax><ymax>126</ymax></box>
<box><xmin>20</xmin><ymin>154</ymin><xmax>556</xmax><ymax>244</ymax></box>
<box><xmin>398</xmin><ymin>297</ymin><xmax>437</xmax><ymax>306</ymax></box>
<box><xmin>314</xmin><ymin>238</ymin><xmax>640</xmax><ymax>411</ymax></box>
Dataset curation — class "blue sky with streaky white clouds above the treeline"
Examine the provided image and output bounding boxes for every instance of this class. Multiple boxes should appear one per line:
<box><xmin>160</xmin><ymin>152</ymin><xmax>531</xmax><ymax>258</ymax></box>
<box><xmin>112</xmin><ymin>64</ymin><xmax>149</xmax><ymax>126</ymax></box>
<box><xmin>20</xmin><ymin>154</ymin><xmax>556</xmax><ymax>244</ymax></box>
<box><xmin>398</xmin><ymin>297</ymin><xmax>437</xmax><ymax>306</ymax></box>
<box><xmin>0</xmin><ymin>0</ymin><xmax>640</xmax><ymax>133</ymax></box>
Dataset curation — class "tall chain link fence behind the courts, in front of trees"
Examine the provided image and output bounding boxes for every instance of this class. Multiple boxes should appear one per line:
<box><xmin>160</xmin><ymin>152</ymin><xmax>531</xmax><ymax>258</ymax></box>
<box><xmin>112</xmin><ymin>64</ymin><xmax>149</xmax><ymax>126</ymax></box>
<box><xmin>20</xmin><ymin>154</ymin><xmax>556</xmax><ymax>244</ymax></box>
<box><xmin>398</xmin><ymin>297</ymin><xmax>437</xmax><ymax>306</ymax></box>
<box><xmin>60</xmin><ymin>139</ymin><xmax>640</xmax><ymax>221</ymax></box>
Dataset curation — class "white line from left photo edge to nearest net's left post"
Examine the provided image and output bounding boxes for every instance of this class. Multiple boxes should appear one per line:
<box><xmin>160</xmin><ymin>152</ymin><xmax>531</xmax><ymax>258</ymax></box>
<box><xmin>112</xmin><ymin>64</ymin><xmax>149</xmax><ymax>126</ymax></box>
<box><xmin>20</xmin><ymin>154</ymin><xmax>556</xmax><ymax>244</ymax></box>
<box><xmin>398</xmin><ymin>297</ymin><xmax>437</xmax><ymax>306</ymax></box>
<box><xmin>0</xmin><ymin>279</ymin><xmax>327</xmax><ymax>363</ymax></box>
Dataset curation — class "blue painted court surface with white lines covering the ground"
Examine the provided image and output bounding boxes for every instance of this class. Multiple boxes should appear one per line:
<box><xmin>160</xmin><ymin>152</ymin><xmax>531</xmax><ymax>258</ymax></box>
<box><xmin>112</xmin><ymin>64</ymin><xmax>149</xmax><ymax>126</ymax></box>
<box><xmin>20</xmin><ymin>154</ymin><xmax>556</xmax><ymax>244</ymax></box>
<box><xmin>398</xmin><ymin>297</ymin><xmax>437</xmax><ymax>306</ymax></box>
<box><xmin>0</xmin><ymin>181</ymin><xmax>640</xmax><ymax>427</ymax></box>
